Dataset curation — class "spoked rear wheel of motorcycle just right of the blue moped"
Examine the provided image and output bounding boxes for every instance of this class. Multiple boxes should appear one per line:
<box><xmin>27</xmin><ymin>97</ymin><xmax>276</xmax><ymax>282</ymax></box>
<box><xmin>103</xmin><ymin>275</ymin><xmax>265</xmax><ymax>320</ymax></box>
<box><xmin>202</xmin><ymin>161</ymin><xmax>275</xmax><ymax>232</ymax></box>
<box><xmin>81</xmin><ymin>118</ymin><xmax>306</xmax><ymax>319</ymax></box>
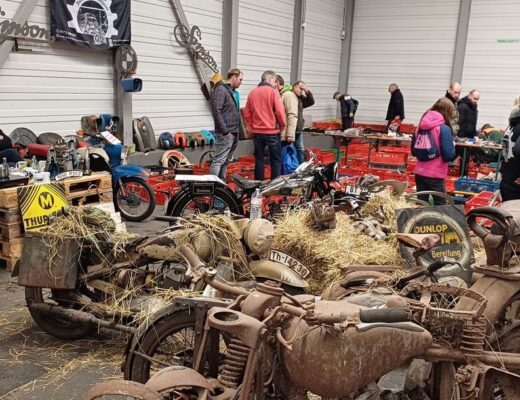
<box><xmin>170</xmin><ymin>187</ymin><xmax>242</xmax><ymax>218</ymax></box>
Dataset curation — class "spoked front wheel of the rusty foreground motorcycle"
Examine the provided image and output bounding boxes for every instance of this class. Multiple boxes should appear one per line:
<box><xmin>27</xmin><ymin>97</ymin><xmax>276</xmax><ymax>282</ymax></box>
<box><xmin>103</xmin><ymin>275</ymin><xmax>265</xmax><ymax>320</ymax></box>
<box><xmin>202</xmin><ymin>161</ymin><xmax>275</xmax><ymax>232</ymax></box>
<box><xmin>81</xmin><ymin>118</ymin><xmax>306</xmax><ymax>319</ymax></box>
<box><xmin>124</xmin><ymin>311</ymin><xmax>226</xmax><ymax>383</ymax></box>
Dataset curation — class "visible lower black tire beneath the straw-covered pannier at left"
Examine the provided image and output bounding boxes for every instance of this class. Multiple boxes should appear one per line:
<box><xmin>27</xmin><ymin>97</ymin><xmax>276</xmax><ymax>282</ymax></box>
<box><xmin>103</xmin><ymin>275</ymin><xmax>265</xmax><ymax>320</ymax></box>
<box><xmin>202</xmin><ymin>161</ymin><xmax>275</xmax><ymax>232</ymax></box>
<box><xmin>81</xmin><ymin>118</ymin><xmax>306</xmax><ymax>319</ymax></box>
<box><xmin>25</xmin><ymin>287</ymin><xmax>95</xmax><ymax>340</ymax></box>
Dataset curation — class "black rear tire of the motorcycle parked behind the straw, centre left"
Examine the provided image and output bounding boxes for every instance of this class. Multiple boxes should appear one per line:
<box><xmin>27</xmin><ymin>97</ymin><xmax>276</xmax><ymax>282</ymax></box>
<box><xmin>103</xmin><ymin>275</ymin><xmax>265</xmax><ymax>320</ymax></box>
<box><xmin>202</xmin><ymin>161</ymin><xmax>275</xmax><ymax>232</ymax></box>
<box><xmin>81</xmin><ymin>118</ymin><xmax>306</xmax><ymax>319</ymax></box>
<box><xmin>168</xmin><ymin>187</ymin><xmax>242</xmax><ymax>217</ymax></box>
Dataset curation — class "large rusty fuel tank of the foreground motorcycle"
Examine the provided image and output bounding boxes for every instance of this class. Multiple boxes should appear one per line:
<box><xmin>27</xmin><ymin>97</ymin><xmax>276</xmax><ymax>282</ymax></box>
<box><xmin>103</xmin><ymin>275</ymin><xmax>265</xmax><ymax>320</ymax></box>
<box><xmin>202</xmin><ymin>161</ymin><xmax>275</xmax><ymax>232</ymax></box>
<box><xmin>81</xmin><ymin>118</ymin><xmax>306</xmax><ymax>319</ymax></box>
<box><xmin>282</xmin><ymin>300</ymin><xmax>432</xmax><ymax>398</ymax></box>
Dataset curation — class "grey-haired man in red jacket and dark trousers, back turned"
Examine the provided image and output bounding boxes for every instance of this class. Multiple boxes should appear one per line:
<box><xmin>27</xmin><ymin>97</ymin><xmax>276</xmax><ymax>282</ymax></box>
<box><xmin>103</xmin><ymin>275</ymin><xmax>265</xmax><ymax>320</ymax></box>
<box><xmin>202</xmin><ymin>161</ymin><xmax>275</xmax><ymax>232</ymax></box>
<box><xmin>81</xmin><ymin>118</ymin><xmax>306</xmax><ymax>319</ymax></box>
<box><xmin>244</xmin><ymin>71</ymin><xmax>285</xmax><ymax>180</ymax></box>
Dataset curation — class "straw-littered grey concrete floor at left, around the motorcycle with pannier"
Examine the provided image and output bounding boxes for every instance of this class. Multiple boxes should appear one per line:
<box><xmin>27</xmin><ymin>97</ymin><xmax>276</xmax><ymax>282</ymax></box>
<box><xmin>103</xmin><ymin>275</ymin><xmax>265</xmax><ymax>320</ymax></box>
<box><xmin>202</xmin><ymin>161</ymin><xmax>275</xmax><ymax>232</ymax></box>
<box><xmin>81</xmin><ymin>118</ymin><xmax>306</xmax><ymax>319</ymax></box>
<box><xmin>0</xmin><ymin>206</ymin><xmax>168</xmax><ymax>400</ymax></box>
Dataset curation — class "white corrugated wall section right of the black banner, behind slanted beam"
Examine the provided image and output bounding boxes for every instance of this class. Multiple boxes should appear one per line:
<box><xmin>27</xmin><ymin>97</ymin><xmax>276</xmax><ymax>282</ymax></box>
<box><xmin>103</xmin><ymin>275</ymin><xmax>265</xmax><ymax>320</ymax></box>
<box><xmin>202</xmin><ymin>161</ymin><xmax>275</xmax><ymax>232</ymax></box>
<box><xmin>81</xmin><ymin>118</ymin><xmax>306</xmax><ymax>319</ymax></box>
<box><xmin>132</xmin><ymin>0</ymin><xmax>222</xmax><ymax>135</ymax></box>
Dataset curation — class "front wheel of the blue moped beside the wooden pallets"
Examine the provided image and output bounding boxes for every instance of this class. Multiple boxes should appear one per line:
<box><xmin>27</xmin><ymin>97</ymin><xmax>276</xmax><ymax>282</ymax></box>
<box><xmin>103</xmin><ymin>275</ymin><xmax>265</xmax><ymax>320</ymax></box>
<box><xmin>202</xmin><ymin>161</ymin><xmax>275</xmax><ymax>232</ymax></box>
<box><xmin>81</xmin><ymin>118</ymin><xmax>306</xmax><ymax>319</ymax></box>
<box><xmin>115</xmin><ymin>177</ymin><xmax>155</xmax><ymax>222</ymax></box>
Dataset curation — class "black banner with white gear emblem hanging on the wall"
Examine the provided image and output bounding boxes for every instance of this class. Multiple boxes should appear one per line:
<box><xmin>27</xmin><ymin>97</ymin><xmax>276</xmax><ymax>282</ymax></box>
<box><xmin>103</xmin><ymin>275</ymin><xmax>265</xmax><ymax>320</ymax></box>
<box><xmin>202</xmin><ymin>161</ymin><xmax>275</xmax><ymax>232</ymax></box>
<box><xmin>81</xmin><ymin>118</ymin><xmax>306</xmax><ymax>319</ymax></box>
<box><xmin>51</xmin><ymin>0</ymin><xmax>131</xmax><ymax>49</ymax></box>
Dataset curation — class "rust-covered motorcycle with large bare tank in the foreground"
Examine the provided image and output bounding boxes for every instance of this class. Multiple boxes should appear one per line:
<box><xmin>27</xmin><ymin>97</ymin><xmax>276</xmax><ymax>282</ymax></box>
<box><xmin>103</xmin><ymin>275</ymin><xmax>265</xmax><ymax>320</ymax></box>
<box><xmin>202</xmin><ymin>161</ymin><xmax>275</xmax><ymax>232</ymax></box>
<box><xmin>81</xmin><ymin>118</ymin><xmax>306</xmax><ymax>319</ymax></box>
<box><xmin>87</xmin><ymin>241</ymin><xmax>520</xmax><ymax>400</ymax></box>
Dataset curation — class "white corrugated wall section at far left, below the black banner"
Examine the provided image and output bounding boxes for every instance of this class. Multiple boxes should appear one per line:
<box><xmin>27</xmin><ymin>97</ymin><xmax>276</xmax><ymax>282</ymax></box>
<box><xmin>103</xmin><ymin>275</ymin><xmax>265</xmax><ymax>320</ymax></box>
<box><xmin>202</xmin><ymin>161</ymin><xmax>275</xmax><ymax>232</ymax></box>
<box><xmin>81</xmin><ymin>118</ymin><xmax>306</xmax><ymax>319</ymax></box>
<box><xmin>0</xmin><ymin>0</ymin><xmax>114</xmax><ymax>135</ymax></box>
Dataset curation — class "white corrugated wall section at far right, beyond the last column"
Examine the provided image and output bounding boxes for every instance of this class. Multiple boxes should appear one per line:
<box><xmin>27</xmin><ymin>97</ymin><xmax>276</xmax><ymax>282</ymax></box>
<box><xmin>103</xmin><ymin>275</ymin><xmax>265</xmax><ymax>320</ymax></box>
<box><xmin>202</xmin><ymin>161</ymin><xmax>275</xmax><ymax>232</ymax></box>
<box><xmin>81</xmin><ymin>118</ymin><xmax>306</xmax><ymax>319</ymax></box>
<box><xmin>462</xmin><ymin>0</ymin><xmax>520</xmax><ymax>128</ymax></box>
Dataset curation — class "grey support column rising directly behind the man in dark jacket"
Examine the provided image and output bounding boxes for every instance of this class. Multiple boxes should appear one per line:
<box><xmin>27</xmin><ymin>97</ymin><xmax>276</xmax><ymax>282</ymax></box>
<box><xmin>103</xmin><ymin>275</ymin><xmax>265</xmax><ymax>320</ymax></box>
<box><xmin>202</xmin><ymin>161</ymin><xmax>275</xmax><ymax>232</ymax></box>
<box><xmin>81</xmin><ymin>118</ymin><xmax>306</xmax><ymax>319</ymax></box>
<box><xmin>220</xmin><ymin>0</ymin><xmax>240</xmax><ymax>74</ymax></box>
